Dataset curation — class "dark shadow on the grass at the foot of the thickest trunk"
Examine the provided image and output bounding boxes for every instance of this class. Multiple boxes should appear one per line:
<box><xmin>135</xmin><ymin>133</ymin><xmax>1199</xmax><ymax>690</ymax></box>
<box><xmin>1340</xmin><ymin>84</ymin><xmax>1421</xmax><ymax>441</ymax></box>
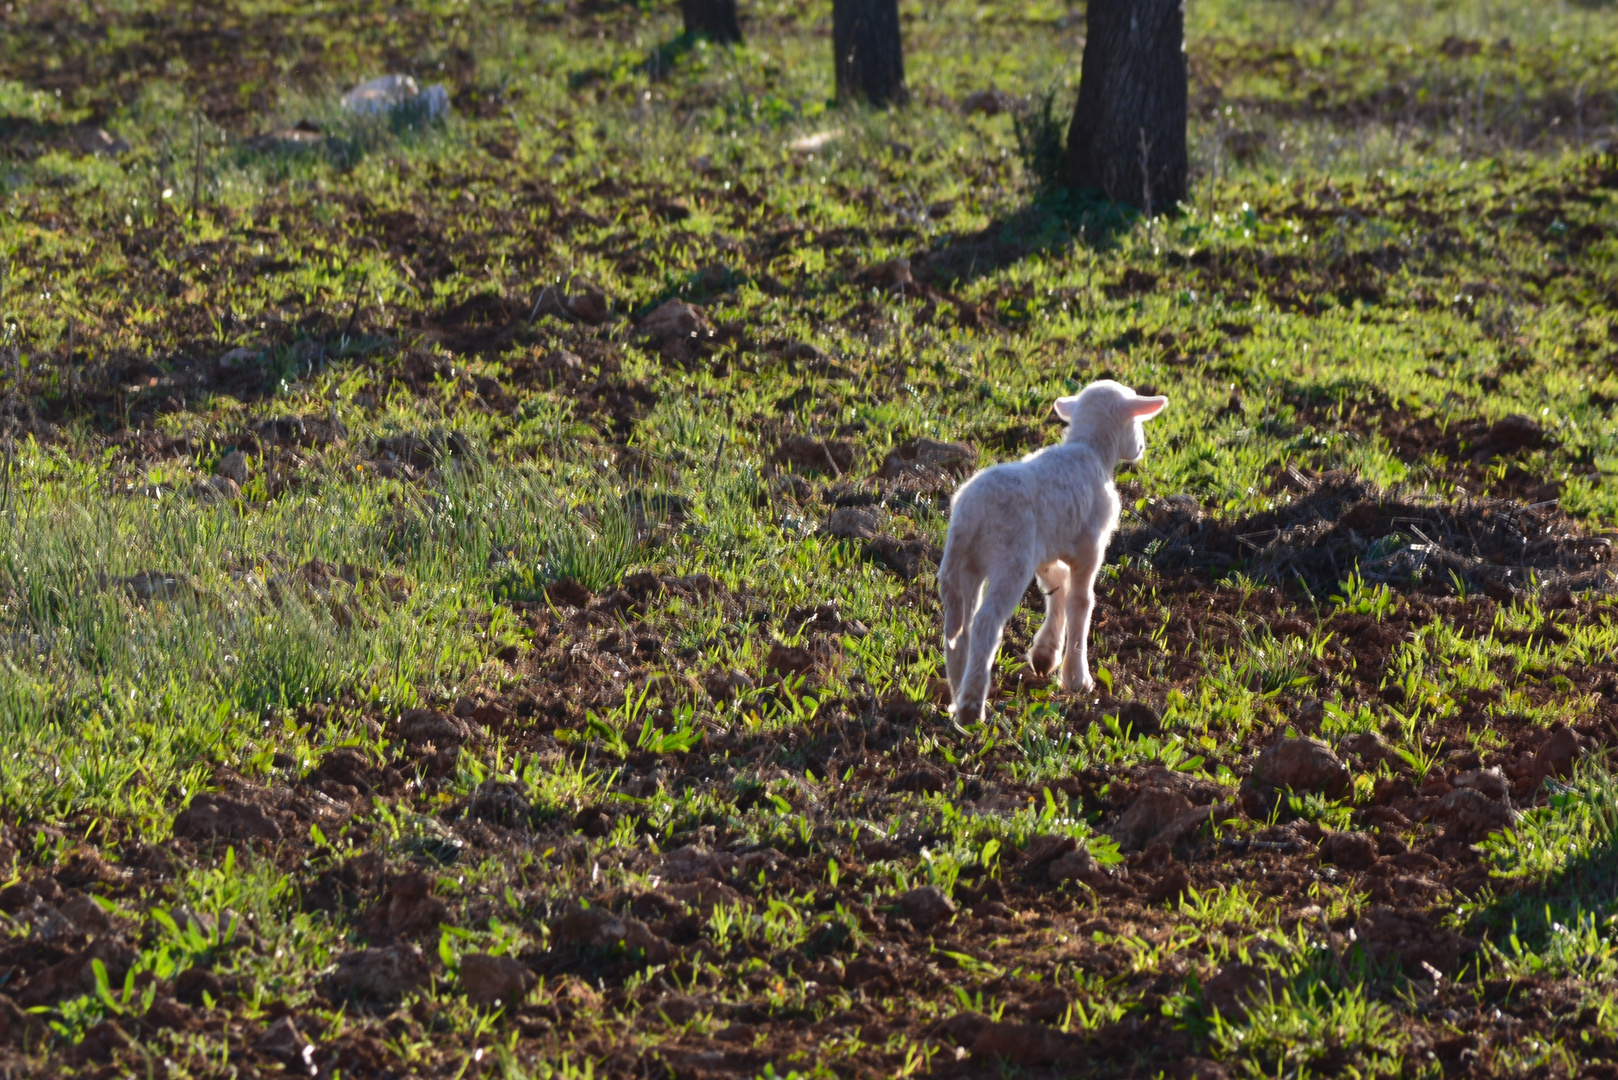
<box><xmin>913</xmin><ymin>189</ymin><xmax>1141</xmax><ymax>285</ymax></box>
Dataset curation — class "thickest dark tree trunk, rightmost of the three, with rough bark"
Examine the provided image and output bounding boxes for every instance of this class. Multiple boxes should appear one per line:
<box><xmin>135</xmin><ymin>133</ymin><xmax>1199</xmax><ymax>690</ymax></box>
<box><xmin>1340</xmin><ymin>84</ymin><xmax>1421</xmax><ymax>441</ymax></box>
<box><xmin>1068</xmin><ymin>0</ymin><xmax>1189</xmax><ymax>214</ymax></box>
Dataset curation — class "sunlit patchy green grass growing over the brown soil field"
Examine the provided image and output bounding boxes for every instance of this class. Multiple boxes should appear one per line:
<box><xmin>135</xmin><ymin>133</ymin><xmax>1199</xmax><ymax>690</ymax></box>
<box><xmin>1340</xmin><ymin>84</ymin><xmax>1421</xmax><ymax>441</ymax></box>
<box><xmin>0</xmin><ymin>0</ymin><xmax>1618</xmax><ymax>1077</ymax></box>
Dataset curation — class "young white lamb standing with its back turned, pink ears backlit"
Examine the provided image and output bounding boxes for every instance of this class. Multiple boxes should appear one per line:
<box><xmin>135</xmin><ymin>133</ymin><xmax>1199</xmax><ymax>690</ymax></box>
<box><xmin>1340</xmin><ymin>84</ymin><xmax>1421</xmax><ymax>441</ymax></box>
<box><xmin>938</xmin><ymin>379</ymin><xmax>1168</xmax><ymax>724</ymax></box>
